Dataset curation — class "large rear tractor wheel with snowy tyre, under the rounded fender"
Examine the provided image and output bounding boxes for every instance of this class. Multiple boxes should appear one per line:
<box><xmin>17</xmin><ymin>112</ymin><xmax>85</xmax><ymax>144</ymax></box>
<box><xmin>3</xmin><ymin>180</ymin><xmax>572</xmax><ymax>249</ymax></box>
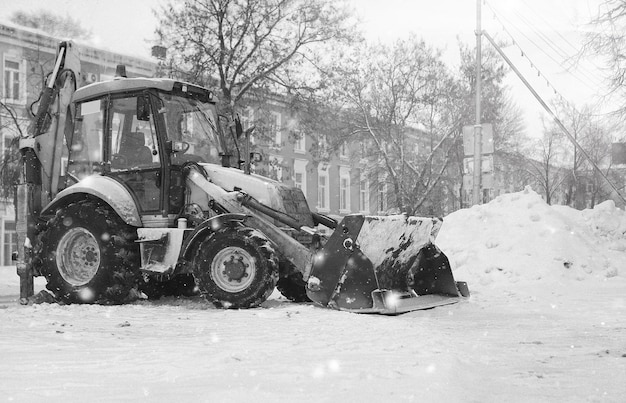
<box><xmin>35</xmin><ymin>200</ymin><xmax>139</xmax><ymax>303</ymax></box>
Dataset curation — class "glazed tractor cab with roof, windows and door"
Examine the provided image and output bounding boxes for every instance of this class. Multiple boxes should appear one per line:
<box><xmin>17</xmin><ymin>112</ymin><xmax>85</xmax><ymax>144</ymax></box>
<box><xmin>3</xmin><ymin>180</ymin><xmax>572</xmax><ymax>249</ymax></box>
<box><xmin>65</xmin><ymin>78</ymin><xmax>227</xmax><ymax>225</ymax></box>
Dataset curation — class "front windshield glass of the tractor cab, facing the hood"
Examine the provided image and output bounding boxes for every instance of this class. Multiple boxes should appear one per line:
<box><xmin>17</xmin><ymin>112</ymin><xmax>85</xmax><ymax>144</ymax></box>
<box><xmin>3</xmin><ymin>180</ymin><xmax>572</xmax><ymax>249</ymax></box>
<box><xmin>158</xmin><ymin>93</ymin><xmax>222</xmax><ymax>164</ymax></box>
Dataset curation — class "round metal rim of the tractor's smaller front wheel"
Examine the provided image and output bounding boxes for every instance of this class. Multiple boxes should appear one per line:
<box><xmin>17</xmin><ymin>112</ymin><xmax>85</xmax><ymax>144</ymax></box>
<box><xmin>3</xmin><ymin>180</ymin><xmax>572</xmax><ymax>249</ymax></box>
<box><xmin>211</xmin><ymin>246</ymin><xmax>256</xmax><ymax>293</ymax></box>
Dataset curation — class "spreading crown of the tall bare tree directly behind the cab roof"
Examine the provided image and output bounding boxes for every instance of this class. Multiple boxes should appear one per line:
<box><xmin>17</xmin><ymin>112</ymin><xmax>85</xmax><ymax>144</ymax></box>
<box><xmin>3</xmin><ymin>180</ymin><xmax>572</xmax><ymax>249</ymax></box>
<box><xmin>157</xmin><ymin>0</ymin><xmax>353</xmax><ymax>115</ymax></box>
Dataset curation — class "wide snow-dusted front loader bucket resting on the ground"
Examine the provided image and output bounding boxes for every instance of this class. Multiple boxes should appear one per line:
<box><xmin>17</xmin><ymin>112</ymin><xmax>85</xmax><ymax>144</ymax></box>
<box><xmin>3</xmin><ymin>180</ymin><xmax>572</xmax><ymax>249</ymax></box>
<box><xmin>307</xmin><ymin>215</ymin><xmax>468</xmax><ymax>315</ymax></box>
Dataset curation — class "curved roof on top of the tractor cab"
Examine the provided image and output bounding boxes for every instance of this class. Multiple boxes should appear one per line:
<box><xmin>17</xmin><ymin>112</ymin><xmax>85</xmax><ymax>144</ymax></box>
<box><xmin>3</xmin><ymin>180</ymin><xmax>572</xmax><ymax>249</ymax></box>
<box><xmin>73</xmin><ymin>77</ymin><xmax>208</xmax><ymax>102</ymax></box>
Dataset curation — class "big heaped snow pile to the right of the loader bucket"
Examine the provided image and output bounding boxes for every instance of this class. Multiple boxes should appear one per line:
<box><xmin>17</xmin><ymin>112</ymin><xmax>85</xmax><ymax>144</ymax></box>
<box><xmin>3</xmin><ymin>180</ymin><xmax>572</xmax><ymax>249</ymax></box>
<box><xmin>436</xmin><ymin>188</ymin><xmax>626</xmax><ymax>288</ymax></box>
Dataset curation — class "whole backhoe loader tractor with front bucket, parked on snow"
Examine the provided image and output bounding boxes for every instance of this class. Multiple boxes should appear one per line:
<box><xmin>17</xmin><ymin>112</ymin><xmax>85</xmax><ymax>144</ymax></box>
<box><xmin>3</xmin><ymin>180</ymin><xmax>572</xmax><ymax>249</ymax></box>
<box><xmin>16</xmin><ymin>42</ymin><xmax>468</xmax><ymax>314</ymax></box>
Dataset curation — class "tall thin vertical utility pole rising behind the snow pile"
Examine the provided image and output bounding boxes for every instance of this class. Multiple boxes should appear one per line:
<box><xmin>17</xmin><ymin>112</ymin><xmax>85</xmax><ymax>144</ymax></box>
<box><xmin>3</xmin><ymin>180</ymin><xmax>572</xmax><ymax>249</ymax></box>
<box><xmin>472</xmin><ymin>0</ymin><xmax>482</xmax><ymax>204</ymax></box>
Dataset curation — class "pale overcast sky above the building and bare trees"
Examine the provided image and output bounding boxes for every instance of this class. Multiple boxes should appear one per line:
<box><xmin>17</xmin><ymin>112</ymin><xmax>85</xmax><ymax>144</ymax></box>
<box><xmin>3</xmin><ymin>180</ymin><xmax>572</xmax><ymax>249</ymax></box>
<box><xmin>0</xmin><ymin>0</ymin><xmax>602</xmax><ymax>137</ymax></box>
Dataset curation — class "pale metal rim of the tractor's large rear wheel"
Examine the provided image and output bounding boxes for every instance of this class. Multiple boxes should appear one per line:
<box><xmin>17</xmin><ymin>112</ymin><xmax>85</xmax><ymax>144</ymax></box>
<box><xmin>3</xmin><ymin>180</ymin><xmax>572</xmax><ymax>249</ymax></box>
<box><xmin>56</xmin><ymin>227</ymin><xmax>100</xmax><ymax>286</ymax></box>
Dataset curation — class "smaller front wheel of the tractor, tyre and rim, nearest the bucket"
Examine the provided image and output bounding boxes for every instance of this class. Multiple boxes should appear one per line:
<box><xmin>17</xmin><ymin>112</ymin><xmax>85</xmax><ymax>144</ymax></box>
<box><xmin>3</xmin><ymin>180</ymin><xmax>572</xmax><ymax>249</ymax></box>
<box><xmin>193</xmin><ymin>227</ymin><xmax>278</xmax><ymax>308</ymax></box>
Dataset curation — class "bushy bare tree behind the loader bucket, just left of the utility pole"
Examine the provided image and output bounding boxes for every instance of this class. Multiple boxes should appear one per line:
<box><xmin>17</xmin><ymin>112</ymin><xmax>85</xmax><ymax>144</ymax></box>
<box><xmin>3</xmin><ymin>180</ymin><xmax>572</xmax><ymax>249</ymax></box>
<box><xmin>312</xmin><ymin>37</ymin><xmax>460</xmax><ymax>218</ymax></box>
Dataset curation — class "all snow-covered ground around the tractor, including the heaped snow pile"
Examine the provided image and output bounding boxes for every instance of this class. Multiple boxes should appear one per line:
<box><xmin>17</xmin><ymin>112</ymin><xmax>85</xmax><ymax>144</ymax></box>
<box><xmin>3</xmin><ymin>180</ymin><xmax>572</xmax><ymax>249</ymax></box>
<box><xmin>0</xmin><ymin>190</ymin><xmax>626</xmax><ymax>402</ymax></box>
